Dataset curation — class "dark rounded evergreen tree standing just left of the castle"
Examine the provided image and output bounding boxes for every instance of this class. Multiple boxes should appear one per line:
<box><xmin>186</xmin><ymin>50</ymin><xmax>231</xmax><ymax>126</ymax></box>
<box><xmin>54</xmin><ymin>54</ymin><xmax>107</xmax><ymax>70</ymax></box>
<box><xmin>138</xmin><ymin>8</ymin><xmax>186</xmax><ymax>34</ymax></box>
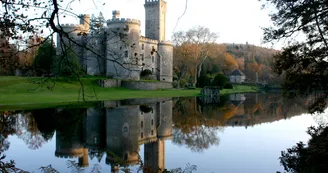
<box><xmin>33</xmin><ymin>40</ymin><xmax>56</xmax><ymax>75</ymax></box>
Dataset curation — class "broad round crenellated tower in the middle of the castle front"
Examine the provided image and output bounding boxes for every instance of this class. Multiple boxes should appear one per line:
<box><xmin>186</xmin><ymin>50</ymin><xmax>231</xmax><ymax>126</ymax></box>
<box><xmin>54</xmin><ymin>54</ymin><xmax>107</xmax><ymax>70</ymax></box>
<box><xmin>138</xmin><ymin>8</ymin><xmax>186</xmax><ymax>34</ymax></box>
<box><xmin>106</xmin><ymin>17</ymin><xmax>141</xmax><ymax>80</ymax></box>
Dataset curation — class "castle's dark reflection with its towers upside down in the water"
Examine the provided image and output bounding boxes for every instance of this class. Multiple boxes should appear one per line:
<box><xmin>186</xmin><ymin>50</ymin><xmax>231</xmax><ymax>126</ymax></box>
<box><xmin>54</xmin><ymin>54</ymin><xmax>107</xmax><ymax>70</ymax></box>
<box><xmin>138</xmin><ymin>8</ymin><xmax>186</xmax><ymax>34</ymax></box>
<box><xmin>55</xmin><ymin>99</ymin><xmax>172</xmax><ymax>172</ymax></box>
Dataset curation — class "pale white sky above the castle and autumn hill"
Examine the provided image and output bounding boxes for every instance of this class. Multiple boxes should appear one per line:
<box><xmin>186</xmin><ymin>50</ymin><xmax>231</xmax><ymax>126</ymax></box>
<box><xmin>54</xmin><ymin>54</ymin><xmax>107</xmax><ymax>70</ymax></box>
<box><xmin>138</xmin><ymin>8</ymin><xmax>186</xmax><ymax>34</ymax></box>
<box><xmin>62</xmin><ymin>0</ymin><xmax>280</xmax><ymax>48</ymax></box>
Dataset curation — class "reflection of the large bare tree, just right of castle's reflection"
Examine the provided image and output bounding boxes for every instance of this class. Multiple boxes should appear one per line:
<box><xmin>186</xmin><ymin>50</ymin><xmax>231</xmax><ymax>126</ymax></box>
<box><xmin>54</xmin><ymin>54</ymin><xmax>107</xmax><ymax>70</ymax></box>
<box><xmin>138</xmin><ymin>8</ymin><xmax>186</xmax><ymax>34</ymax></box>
<box><xmin>173</xmin><ymin>98</ymin><xmax>222</xmax><ymax>152</ymax></box>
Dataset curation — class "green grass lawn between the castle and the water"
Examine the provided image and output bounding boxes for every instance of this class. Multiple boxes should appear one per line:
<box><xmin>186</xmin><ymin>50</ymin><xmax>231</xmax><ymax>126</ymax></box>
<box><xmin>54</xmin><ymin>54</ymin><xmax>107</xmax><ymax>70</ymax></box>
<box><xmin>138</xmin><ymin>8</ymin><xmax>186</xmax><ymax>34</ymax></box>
<box><xmin>0</xmin><ymin>77</ymin><xmax>258</xmax><ymax>110</ymax></box>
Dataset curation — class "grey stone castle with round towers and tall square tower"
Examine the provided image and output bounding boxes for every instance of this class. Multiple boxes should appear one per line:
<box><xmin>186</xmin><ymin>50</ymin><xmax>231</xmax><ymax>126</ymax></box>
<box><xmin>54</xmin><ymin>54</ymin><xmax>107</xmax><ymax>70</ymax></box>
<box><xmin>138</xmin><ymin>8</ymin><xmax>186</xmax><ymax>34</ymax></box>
<box><xmin>57</xmin><ymin>0</ymin><xmax>173</xmax><ymax>82</ymax></box>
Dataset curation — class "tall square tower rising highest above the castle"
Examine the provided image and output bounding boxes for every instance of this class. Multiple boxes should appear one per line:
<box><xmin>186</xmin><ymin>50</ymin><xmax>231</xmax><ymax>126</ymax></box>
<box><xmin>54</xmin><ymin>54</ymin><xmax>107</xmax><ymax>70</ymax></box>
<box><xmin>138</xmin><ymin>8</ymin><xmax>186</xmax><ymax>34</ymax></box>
<box><xmin>145</xmin><ymin>0</ymin><xmax>166</xmax><ymax>41</ymax></box>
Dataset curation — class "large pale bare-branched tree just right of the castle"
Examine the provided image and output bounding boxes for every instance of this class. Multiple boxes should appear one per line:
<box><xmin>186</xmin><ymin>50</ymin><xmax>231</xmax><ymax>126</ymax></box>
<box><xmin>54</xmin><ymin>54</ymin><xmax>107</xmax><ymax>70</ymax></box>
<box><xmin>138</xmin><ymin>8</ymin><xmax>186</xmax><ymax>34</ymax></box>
<box><xmin>173</xmin><ymin>26</ymin><xmax>218</xmax><ymax>84</ymax></box>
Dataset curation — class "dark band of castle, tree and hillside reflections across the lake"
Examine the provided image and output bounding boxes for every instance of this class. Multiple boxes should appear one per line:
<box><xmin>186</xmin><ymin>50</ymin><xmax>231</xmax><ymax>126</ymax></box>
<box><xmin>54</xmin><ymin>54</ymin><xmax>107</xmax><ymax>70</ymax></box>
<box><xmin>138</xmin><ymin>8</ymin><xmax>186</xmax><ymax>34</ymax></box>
<box><xmin>0</xmin><ymin>93</ymin><xmax>309</xmax><ymax>173</ymax></box>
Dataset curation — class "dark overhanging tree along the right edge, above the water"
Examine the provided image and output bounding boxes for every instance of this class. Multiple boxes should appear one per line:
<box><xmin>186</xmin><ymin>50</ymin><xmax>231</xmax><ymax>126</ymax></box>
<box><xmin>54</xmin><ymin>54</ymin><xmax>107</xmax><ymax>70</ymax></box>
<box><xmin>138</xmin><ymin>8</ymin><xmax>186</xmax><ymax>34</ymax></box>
<box><xmin>262</xmin><ymin>0</ymin><xmax>328</xmax><ymax>112</ymax></box>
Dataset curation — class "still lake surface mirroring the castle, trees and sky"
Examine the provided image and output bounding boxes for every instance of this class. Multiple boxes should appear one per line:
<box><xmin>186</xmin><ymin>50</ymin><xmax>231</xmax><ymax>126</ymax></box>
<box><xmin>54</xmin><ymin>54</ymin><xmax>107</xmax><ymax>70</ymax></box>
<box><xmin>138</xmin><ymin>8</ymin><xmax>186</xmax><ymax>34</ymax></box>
<box><xmin>0</xmin><ymin>93</ymin><xmax>320</xmax><ymax>173</ymax></box>
